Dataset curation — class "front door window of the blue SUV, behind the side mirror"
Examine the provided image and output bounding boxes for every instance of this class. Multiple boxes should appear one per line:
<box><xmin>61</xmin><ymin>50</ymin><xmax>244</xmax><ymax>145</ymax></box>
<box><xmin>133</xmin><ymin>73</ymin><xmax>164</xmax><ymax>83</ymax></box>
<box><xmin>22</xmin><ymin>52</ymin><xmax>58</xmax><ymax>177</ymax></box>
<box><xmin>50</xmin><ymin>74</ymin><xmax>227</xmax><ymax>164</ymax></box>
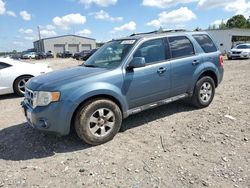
<box><xmin>134</xmin><ymin>39</ymin><xmax>166</xmax><ymax>64</ymax></box>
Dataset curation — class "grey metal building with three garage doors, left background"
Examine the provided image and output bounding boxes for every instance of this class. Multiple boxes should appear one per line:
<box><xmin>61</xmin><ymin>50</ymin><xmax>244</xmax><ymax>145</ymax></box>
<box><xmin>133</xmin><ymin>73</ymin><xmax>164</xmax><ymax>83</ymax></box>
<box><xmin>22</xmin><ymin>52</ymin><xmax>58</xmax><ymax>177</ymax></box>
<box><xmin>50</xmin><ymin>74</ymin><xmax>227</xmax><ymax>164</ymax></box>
<box><xmin>33</xmin><ymin>35</ymin><xmax>96</xmax><ymax>54</ymax></box>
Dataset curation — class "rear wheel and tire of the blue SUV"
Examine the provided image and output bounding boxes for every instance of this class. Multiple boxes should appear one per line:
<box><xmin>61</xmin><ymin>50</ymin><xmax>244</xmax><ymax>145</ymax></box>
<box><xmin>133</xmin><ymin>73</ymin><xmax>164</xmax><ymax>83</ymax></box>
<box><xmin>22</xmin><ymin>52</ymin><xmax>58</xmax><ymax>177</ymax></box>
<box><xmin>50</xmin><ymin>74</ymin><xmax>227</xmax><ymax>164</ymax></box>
<box><xmin>191</xmin><ymin>76</ymin><xmax>215</xmax><ymax>108</ymax></box>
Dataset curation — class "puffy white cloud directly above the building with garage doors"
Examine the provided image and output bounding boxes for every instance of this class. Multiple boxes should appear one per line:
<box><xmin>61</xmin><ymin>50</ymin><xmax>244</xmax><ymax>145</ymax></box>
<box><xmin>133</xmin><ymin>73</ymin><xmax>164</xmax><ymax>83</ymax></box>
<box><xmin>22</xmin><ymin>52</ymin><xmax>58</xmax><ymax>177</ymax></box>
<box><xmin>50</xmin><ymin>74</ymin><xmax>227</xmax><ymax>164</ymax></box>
<box><xmin>53</xmin><ymin>13</ymin><xmax>86</xmax><ymax>30</ymax></box>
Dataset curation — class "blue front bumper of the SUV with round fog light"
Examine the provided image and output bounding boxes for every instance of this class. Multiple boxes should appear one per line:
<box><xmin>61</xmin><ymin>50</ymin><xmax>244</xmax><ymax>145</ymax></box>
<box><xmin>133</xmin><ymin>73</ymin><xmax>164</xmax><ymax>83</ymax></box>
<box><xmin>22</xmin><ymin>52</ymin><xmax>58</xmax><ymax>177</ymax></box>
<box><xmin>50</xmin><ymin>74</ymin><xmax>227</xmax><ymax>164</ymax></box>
<box><xmin>21</xmin><ymin>101</ymin><xmax>71</xmax><ymax>136</ymax></box>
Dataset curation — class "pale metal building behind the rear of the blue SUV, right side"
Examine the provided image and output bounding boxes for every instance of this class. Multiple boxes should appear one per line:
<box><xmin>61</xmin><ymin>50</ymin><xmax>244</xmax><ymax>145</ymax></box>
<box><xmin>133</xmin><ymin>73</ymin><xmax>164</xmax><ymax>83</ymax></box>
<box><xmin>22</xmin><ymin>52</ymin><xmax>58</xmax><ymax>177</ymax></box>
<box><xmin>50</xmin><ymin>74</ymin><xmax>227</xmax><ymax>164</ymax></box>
<box><xmin>206</xmin><ymin>29</ymin><xmax>250</xmax><ymax>53</ymax></box>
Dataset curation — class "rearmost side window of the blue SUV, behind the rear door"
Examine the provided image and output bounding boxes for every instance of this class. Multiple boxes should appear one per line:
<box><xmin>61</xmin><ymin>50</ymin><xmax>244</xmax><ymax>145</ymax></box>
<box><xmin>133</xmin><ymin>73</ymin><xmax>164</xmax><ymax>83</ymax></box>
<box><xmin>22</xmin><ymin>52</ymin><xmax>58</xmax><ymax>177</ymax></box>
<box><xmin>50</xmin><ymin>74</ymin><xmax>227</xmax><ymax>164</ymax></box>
<box><xmin>193</xmin><ymin>34</ymin><xmax>217</xmax><ymax>53</ymax></box>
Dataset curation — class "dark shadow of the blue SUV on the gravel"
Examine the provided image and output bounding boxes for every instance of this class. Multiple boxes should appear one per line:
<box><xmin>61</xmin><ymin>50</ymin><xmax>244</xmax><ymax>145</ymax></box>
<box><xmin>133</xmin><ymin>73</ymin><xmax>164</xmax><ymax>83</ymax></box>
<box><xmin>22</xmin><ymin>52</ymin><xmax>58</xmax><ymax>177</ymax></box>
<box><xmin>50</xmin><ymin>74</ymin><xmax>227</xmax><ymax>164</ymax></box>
<box><xmin>0</xmin><ymin>102</ymin><xmax>194</xmax><ymax>161</ymax></box>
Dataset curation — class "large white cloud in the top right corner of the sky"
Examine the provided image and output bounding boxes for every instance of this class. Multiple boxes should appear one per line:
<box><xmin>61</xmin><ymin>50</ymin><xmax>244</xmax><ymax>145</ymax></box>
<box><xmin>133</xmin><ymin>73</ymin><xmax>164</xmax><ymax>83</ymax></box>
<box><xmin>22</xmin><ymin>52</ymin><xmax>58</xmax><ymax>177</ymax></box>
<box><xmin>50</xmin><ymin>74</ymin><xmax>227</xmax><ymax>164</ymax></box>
<box><xmin>198</xmin><ymin>0</ymin><xmax>250</xmax><ymax>17</ymax></box>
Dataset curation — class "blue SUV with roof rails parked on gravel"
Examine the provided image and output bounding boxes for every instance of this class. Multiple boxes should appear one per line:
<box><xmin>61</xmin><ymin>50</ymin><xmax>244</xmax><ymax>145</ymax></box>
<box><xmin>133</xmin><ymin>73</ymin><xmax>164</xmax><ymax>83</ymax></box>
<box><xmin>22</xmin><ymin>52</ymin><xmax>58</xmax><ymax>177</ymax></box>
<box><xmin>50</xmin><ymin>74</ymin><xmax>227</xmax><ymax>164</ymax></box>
<box><xmin>22</xmin><ymin>32</ymin><xmax>224</xmax><ymax>145</ymax></box>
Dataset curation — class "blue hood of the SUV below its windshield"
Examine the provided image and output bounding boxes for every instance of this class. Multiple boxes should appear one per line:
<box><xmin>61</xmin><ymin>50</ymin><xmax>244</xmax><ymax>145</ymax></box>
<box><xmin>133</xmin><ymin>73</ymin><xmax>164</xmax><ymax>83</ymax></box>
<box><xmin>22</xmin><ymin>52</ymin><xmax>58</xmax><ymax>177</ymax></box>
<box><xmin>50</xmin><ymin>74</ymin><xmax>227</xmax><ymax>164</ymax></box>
<box><xmin>27</xmin><ymin>66</ymin><xmax>108</xmax><ymax>91</ymax></box>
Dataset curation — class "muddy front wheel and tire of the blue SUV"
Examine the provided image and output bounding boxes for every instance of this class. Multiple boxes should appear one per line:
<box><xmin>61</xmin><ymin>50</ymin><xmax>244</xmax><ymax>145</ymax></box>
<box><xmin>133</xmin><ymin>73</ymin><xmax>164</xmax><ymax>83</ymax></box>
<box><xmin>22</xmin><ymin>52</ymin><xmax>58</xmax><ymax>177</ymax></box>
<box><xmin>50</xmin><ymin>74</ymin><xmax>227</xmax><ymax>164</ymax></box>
<box><xmin>74</xmin><ymin>99</ymin><xmax>122</xmax><ymax>145</ymax></box>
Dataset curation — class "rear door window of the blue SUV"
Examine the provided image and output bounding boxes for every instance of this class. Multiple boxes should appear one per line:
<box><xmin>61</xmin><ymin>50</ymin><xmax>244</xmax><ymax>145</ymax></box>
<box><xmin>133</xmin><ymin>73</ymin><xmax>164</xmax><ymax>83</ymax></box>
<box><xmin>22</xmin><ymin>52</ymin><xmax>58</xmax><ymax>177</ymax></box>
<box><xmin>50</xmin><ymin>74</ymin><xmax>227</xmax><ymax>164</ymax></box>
<box><xmin>168</xmin><ymin>36</ymin><xmax>195</xmax><ymax>58</ymax></box>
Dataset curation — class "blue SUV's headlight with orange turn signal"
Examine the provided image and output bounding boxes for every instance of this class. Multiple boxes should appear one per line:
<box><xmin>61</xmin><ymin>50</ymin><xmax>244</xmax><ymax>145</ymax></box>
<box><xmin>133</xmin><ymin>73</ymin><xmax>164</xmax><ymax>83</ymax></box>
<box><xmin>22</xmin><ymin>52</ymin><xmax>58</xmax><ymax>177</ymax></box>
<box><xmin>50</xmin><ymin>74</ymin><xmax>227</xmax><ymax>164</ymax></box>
<box><xmin>33</xmin><ymin>91</ymin><xmax>60</xmax><ymax>107</ymax></box>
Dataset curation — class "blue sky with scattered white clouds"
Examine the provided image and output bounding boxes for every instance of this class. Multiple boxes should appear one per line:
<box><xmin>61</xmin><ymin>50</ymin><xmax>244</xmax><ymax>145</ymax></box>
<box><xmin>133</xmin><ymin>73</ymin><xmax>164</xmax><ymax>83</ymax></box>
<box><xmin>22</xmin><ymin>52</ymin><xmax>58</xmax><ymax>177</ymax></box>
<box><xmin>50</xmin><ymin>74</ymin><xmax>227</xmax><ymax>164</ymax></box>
<box><xmin>0</xmin><ymin>0</ymin><xmax>250</xmax><ymax>52</ymax></box>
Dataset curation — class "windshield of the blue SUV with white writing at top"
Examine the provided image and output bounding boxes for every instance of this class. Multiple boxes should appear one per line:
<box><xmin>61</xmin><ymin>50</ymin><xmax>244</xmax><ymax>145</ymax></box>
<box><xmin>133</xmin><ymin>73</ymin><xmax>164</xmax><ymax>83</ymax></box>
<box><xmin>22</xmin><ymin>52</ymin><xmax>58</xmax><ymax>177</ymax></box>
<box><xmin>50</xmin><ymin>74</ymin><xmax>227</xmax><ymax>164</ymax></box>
<box><xmin>83</xmin><ymin>40</ymin><xmax>136</xmax><ymax>69</ymax></box>
